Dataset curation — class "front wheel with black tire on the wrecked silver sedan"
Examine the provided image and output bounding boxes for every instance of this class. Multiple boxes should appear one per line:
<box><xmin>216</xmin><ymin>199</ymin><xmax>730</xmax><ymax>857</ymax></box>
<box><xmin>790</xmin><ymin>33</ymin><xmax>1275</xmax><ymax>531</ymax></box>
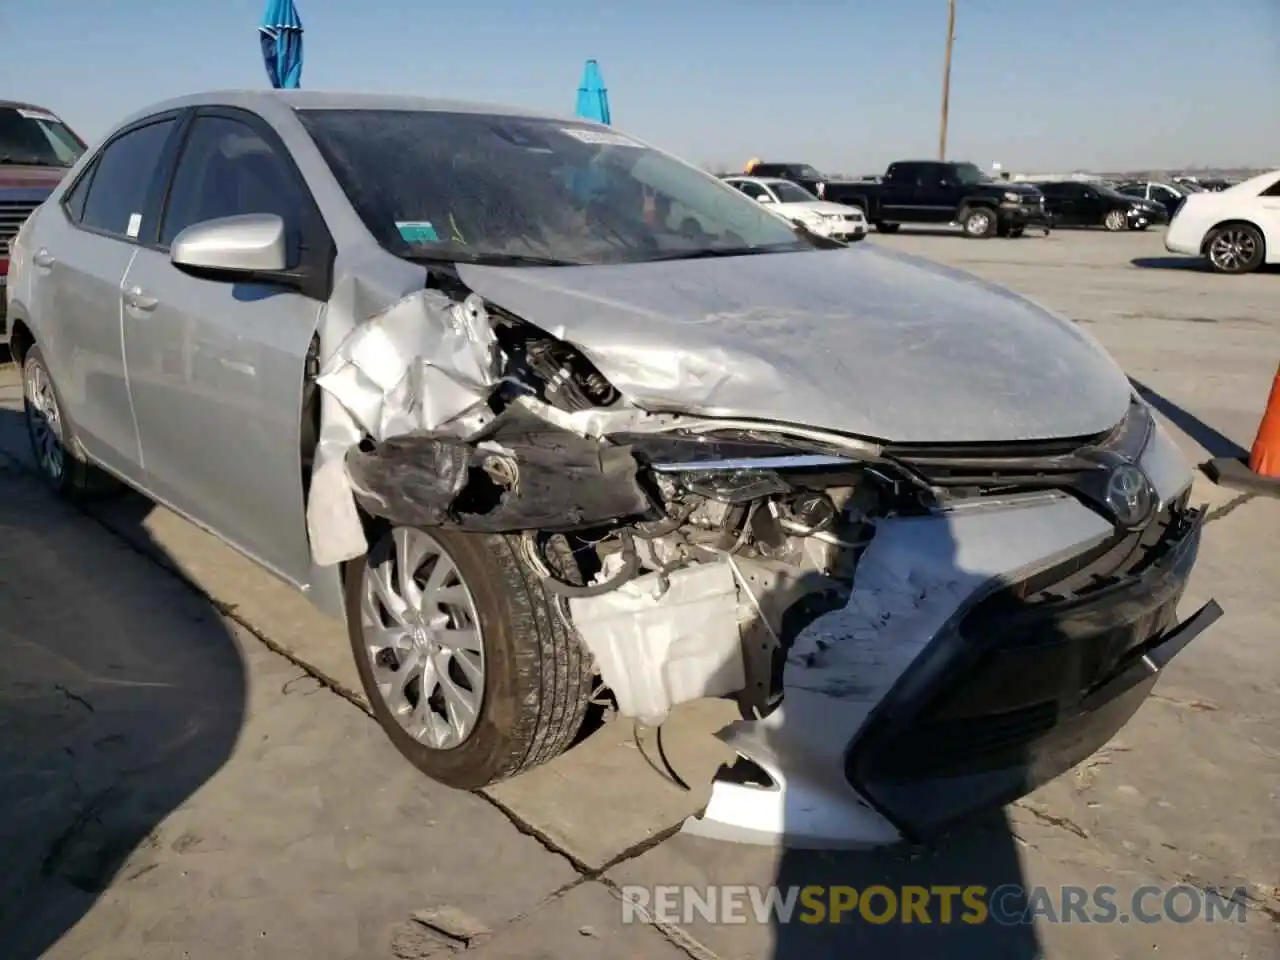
<box><xmin>343</xmin><ymin>527</ymin><xmax>593</xmax><ymax>790</ymax></box>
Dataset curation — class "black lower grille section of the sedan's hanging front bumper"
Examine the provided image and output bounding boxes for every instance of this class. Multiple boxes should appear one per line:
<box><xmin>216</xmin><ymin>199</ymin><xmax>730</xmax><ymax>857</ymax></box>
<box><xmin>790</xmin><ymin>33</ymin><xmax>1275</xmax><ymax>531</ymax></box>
<box><xmin>846</xmin><ymin>511</ymin><xmax>1221</xmax><ymax>840</ymax></box>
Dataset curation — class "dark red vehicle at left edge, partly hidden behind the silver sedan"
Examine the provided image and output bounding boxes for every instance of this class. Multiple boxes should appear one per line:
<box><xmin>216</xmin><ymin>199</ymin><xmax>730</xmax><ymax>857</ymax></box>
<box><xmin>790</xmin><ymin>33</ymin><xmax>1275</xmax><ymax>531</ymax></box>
<box><xmin>0</xmin><ymin>100</ymin><xmax>84</xmax><ymax>337</ymax></box>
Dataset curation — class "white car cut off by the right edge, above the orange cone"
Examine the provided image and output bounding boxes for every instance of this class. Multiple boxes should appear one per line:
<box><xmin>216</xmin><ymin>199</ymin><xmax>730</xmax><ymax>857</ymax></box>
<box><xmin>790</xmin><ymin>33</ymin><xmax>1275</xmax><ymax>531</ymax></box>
<box><xmin>1165</xmin><ymin>170</ymin><xmax>1280</xmax><ymax>274</ymax></box>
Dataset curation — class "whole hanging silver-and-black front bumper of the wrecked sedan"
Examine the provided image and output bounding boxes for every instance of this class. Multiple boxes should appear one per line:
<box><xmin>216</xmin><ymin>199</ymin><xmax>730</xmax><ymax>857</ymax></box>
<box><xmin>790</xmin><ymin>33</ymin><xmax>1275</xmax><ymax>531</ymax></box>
<box><xmin>685</xmin><ymin>428</ymin><xmax>1221</xmax><ymax>849</ymax></box>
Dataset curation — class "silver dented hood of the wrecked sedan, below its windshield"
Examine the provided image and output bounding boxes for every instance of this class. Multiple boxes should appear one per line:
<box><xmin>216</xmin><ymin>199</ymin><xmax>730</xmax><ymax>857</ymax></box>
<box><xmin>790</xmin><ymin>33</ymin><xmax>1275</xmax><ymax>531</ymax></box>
<box><xmin>458</xmin><ymin>244</ymin><xmax>1130</xmax><ymax>443</ymax></box>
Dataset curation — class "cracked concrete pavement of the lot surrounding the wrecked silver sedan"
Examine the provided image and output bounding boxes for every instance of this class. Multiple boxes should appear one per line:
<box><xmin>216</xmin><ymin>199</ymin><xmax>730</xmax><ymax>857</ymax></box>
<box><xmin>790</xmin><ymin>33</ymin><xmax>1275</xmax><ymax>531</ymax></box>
<box><xmin>0</xmin><ymin>232</ymin><xmax>1280</xmax><ymax>957</ymax></box>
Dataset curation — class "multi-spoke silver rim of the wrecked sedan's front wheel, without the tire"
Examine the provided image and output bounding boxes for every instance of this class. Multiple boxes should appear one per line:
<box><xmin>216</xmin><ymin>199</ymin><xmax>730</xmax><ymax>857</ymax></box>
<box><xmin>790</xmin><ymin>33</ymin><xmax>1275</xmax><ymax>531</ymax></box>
<box><xmin>360</xmin><ymin>527</ymin><xmax>485</xmax><ymax>750</ymax></box>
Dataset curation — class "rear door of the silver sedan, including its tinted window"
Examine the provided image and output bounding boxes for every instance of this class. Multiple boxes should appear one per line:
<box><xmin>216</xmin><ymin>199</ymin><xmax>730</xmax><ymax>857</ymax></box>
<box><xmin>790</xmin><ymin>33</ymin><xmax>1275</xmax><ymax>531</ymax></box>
<box><xmin>31</xmin><ymin>113</ymin><xmax>179</xmax><ymax>481</ymax></box>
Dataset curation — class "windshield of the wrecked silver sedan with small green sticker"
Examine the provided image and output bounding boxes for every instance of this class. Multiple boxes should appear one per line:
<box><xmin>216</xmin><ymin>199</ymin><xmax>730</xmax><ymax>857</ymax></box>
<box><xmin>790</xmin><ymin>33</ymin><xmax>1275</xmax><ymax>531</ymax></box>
<box><xmin>298</xmin><ymin>110</ymin><xmax>814</xmax><ymax>265</ymax></box>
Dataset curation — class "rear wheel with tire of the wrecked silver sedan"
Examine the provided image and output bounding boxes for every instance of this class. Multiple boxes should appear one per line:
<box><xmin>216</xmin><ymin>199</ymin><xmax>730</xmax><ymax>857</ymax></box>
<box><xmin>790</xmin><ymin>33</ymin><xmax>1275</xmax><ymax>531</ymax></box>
<box><xmin>22</xmin><ymin>344</ymin><xmax>120</xmax><ymax>500</ymax></box>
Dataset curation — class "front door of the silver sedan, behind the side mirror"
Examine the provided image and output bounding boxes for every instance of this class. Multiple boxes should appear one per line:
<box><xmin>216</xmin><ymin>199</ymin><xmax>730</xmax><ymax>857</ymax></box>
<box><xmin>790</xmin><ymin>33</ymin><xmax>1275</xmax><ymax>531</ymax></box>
<box><xmin>124</xmin><ymin>109</ymin><xmax>332</xmax><ymax>585</ymax></box>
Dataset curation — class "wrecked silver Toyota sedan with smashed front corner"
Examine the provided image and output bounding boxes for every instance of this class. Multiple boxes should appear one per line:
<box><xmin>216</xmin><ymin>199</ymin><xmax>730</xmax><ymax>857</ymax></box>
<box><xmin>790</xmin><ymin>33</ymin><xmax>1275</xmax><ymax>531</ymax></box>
<box><xmin>6</xmin><ymin>91</ymin><xmax>1220</xmax><ymax>845</ymax></box>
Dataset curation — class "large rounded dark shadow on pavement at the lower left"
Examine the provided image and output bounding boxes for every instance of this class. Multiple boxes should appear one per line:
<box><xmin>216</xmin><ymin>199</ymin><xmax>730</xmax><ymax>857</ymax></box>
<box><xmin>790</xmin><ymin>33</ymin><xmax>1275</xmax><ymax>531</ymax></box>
<box><xmin>0</xmin><ymin>410</ymin><xmax>247</xmax><ymax>960</ymax></box>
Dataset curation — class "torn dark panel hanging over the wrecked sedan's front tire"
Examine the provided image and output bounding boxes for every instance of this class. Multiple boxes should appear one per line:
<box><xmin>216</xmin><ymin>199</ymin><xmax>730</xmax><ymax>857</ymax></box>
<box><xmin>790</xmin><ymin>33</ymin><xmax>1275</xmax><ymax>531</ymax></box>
<box><xmin>347</xmin><ymin>431</ymin><xmax>654</xmax><ymax>532</ymax></box>
